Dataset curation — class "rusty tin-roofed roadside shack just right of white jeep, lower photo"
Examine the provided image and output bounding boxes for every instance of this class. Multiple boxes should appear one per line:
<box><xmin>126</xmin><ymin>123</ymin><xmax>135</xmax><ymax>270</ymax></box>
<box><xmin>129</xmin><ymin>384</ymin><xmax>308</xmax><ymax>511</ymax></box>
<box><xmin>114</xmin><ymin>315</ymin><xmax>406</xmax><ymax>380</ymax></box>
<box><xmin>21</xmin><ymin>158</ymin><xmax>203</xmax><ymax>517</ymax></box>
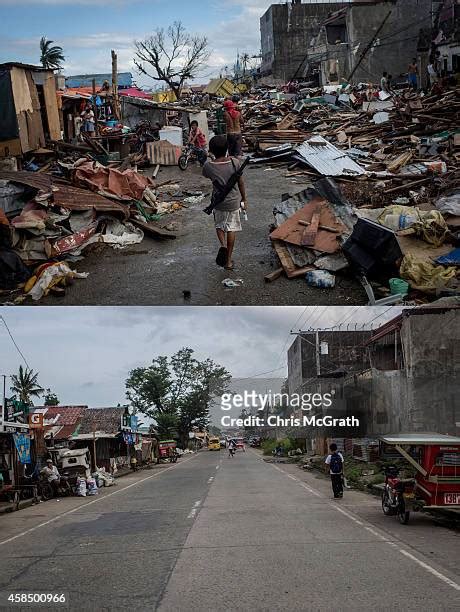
<box><xmin>72</xmin><ymin>406</ymin><xmax>140</xmax><ymax>473</ymax></box>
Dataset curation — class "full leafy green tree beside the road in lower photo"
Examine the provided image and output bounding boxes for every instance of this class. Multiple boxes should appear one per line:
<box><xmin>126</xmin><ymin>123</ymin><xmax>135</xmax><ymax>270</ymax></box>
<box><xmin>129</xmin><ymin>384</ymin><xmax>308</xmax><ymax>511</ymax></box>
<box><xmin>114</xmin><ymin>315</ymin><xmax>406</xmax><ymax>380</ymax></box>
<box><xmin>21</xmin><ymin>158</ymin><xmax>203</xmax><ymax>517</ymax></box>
<box><xmin>126</xmin><ymin>348</ymin><xmax>231</xmax><ymax>441</ymax></box>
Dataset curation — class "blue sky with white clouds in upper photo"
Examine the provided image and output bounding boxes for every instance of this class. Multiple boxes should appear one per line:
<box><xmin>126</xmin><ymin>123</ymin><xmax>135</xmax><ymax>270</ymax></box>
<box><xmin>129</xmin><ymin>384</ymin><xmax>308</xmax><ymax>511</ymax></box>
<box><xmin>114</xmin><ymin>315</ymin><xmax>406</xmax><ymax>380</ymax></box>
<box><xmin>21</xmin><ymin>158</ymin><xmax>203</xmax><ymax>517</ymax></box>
<box><xmin>0</xmin><ymin>0</ymin><xmax>272</xmax><ymax>85</ymax></box>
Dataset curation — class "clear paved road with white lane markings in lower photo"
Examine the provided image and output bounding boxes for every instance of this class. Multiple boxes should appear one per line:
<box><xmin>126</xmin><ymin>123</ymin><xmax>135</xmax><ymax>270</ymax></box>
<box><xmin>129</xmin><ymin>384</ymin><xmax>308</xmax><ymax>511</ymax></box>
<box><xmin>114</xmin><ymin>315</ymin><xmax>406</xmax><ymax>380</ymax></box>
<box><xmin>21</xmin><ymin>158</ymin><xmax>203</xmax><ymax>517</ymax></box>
<box><xmin>0</xmin><ymin>451</ymin><xmax>460</xmax><ymax>612</ymax></box>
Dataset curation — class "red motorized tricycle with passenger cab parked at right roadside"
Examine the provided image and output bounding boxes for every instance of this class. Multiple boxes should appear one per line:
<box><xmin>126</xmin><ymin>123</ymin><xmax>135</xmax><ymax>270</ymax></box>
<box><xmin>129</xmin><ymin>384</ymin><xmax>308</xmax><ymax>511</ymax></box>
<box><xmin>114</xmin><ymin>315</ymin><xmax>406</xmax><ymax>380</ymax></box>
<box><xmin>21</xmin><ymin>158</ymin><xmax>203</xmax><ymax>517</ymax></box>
<box><xmin>380</xmin><ymin>433</ymin><xmax>460</xmax><ymax>525</ymax></box>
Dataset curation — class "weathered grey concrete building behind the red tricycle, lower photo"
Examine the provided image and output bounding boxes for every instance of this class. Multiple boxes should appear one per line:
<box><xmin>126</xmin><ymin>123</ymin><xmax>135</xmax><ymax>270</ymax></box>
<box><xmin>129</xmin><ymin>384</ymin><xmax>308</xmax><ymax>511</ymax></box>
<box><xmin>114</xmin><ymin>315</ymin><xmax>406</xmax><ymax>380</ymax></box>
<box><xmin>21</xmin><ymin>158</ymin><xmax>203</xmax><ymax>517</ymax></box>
<box><xmin>359</xmin><ymin>307</ymin><xmax>460</xmax><ymax>435</ymax></box>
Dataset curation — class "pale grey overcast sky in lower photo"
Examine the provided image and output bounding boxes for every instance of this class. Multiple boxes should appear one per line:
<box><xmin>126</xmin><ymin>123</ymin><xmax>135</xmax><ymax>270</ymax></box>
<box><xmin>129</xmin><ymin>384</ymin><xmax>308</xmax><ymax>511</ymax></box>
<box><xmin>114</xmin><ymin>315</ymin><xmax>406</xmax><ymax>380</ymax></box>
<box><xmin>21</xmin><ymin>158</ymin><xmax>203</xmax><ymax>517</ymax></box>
<box><xmin>0</xmin><ymin>306</ymin><xmax>400</xmax><ymax>407</ymax></box>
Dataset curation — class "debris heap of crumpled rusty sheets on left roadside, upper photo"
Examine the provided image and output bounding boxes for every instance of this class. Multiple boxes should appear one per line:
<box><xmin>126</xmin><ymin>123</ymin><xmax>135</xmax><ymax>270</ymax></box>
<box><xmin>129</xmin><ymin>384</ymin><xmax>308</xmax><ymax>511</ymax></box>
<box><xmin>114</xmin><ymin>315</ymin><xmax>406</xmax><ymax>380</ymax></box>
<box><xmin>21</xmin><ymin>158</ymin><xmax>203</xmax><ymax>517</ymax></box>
<box><xmin>0</xmin><ymin>158</ymin><xmax>182</xmax><ymax>300</ymax></box>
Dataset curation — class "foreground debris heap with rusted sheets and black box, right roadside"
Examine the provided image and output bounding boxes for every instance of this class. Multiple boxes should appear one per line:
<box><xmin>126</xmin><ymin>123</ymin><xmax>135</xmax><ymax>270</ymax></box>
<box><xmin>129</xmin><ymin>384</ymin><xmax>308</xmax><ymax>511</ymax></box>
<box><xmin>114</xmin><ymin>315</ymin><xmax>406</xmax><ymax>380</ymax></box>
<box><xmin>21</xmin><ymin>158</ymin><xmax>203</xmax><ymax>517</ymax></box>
<box><xmin>265</xmin><ymin>173</ymin><xmax>460</xmax><ymax>304</ymax></box>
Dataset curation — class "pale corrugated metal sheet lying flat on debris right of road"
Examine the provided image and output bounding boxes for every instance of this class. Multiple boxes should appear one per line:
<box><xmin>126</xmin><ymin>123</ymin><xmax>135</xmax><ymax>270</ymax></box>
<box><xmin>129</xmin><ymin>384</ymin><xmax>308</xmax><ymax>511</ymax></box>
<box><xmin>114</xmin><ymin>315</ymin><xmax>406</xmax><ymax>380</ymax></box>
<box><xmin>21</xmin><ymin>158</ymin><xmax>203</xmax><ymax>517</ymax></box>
<box><xmin>295</xmin><ymin>135</ymin><xmax>365</xmax><ymax>176</ymax></box>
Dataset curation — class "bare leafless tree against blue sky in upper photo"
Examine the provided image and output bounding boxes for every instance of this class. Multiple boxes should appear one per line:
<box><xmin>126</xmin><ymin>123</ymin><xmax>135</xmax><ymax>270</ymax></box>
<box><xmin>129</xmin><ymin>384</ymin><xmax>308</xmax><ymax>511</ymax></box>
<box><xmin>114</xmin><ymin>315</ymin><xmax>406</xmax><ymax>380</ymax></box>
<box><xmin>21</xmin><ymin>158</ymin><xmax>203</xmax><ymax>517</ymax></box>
<box><xmin>133</xmin><ymin>21</ymin><xmax>210</xmax><ymax>99</ymax></box>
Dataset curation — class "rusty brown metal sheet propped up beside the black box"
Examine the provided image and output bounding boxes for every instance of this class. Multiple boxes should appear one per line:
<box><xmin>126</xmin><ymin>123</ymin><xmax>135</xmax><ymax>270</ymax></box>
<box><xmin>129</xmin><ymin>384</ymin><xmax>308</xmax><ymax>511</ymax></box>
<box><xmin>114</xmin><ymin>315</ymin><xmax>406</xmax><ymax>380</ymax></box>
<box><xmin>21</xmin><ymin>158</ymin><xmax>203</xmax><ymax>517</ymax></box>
<box><xmin>270</xmin><ymin>198</ymin><xmax>346</xmax><ymax>253</ymax></box>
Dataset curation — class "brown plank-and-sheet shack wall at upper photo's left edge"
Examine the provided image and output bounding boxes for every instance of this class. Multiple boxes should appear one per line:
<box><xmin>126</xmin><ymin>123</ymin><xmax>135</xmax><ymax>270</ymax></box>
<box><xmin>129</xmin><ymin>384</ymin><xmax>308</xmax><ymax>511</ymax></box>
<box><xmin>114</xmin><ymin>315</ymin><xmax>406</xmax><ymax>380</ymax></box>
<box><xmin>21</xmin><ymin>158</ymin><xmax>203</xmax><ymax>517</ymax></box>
<box><xmin>0</xmin><ymin>63</ymin><xmax>61</xmax><ymax>157</ymax></box>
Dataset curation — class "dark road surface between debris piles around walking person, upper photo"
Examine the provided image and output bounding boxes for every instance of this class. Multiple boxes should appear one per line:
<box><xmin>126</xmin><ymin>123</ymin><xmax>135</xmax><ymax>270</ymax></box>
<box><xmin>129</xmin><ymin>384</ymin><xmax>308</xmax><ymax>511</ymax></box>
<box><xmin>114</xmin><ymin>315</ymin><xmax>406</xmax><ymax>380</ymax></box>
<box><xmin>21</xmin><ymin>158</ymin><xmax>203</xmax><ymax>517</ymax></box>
<box><xmin>40</xmin><ymin>165</ymin><xmax>367</xmax><ymax>306</ymax></box>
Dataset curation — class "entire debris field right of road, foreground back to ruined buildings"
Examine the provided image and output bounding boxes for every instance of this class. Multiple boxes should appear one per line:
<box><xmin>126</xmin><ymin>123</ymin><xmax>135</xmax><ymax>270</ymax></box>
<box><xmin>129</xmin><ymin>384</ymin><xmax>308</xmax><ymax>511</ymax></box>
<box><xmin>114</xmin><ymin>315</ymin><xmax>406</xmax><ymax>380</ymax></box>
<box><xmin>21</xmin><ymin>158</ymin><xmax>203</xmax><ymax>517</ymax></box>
<box><xmin>253</xmin><ymin>83</ymin><xmax>460</xmax><ymax>303</ymax></box>
